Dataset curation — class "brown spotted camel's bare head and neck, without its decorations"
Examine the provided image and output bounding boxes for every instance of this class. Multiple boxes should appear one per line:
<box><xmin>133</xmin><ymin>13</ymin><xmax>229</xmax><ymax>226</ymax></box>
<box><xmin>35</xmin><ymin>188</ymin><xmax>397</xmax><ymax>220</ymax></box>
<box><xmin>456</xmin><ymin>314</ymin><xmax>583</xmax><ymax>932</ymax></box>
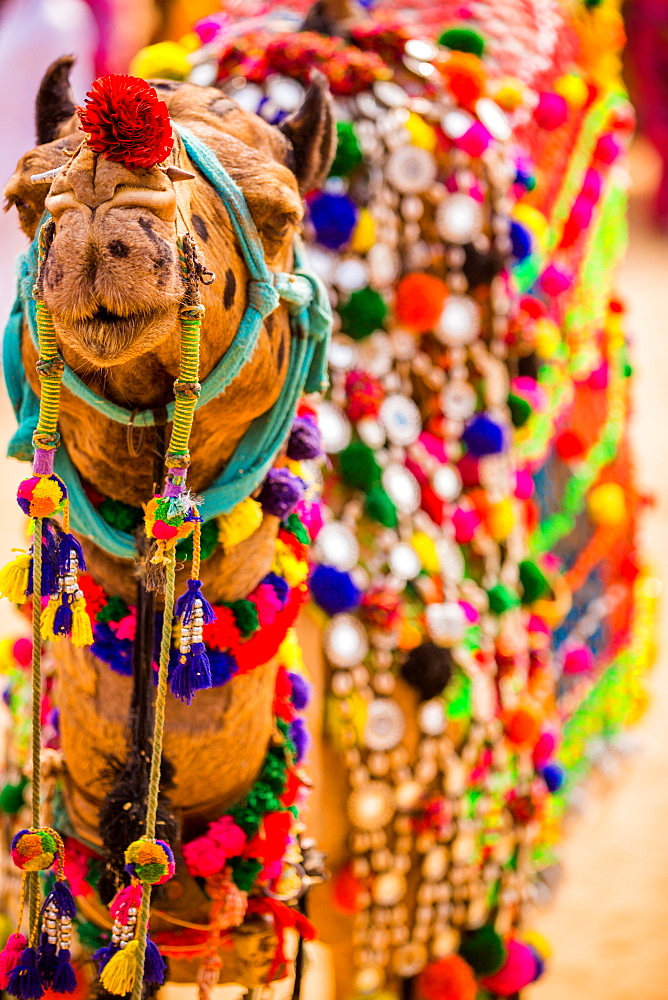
<box><xmin>6</xmin><ymin>57</ymin><xmax>334</xmax><ymax>992</ymax></box>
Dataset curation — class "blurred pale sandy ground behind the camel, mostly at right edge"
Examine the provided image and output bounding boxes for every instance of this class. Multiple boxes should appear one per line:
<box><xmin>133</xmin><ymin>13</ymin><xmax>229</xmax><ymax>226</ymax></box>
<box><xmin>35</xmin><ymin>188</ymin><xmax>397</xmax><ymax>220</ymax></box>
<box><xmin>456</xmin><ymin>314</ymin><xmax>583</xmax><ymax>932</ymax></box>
<box><xmin>0</xmin><ymin>139</ymin><xmax>668</xmax><ymax>1000</ymax></box>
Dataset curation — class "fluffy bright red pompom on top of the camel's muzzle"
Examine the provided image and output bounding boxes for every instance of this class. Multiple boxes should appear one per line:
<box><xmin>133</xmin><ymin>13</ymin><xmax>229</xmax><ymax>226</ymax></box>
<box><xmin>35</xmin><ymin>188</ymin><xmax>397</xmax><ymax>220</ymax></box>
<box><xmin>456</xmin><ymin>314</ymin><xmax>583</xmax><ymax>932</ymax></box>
<box><xmin>77</xmin><ymin>73</ymin><xmax>174</xmax><ymax>170</ymax></box>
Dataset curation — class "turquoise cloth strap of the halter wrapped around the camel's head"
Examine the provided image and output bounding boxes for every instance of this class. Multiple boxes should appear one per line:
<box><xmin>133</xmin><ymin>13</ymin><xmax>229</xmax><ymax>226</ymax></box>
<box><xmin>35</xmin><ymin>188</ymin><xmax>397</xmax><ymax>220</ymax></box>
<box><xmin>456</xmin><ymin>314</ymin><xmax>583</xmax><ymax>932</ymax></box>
<box><xmin>3</xmin><ymin>126</ymin><xmax>332</xmax><ymax>559</ymax></box>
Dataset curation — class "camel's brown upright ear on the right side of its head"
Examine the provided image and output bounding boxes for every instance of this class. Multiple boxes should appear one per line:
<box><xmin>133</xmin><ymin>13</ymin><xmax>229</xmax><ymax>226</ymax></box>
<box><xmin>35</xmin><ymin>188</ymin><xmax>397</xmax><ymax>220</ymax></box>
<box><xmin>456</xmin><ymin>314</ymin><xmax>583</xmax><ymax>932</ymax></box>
<box><xmin>279</xmin><ymin>71</ymin><xmax>336</xmax><ymax>194</ymax></box>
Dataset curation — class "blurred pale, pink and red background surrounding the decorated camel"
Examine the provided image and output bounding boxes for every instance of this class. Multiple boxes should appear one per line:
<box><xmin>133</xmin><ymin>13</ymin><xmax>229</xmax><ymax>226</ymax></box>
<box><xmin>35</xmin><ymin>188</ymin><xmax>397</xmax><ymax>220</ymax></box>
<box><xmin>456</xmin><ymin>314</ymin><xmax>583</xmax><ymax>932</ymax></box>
<box><xmin>0</xmin><ymin>0</ymin><xmax>668</xmax><ymax>1000</ymax></box>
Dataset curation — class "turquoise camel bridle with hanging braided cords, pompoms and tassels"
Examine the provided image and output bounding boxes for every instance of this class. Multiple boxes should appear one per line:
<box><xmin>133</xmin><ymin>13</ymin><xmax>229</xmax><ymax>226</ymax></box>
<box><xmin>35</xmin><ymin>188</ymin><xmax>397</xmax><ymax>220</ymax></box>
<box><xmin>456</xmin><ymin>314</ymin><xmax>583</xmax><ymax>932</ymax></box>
<box><xmin>0</xmin><ymin>77</ymin><xmax>331</xmax><ymax>1000</ymax></box>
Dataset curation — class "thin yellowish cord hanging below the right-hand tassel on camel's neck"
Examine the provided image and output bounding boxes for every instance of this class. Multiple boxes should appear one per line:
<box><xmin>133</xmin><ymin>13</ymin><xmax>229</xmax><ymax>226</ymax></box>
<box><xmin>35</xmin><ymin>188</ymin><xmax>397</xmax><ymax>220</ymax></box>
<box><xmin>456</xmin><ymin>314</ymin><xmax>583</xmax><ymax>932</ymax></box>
<box><xmin>132</xmin><ymin>551</ymin><xmax>176</xmax><ymax>1000</ymax></box>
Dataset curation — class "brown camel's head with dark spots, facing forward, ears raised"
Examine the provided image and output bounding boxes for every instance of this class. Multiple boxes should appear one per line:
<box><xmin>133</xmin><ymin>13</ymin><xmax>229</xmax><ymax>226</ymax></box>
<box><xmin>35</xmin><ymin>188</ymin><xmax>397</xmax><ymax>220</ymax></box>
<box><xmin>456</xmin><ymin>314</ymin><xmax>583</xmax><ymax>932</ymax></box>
<box><xmin>5</xmin><ymin>57</ymin><xmax>335</xmax><ymax>381</ymax></box>
